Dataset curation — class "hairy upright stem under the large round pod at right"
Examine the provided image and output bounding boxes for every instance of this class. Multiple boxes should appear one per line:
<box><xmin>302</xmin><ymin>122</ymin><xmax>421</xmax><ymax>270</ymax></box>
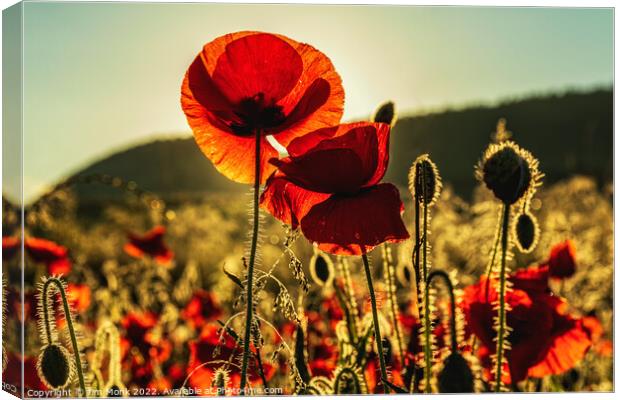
<box><xmin>495</xmin><ymin>204</ymin><xmax>510</xmax><ymax>392</ymax></box>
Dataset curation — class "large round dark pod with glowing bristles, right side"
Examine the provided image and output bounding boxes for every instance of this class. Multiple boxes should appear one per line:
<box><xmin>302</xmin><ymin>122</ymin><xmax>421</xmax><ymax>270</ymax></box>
<box><xmin>476</xmin><ymin>141</ymin><xmax>542</xmax><ymax>205</ymax></box>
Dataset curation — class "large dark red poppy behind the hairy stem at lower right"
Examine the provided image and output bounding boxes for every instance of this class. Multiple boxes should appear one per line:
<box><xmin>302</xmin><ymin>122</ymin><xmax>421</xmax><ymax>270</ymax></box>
<box><xmin>462</xmin><ymin>267</ymin><xmax>591</xmax><ymax>383</ymax></box>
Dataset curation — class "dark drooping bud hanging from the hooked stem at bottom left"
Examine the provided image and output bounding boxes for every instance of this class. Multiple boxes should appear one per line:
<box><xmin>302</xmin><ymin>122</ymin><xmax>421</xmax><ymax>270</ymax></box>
<box><xmin>37</xmin><ymin>344</ymin><xmax>74</xmax><ymax>389</ymax></box>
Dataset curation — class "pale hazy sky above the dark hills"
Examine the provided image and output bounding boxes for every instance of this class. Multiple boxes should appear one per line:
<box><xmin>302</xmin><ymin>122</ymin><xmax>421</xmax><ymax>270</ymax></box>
<box><xmin>9</xmin><ymin>3</ymin><xmax>613</xmax><ymax>199</ymax></box>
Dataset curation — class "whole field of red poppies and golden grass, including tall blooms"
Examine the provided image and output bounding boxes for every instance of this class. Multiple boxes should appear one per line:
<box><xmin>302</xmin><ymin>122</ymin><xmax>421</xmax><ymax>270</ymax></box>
<box><xmin>2</xmin><ymin>31</ymin><xmax>614</xmax><ymax>397</ymax></box>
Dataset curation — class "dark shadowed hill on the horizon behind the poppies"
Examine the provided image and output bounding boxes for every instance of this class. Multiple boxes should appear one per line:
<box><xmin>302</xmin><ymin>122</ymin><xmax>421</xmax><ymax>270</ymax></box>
<box><xmin>60</xmin><ymin>90</ymin><xmax>613</xmax><ymax>202</ymax></box>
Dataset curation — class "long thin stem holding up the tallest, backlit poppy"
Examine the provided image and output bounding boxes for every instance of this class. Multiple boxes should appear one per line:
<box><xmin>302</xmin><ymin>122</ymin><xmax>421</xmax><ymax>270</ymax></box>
<box><xmin>240</xmin><ymin>129</ymin><xmax>261</xmax><ymax>396</ymax></box>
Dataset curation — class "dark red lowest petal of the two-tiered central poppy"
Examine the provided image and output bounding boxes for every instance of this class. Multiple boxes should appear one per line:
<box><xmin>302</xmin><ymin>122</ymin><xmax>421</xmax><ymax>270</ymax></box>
<box><xmin>301</xmin><ymin>183</ymin><xmax>409</xmax><ymax>255</ymax></box>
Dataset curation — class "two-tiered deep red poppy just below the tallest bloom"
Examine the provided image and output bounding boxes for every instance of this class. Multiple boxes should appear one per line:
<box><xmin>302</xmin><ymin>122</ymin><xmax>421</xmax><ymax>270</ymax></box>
<box><xmin>261</xmin><ymin>122</ymin><xmax>409</xmax><ymax>255</ymax></box>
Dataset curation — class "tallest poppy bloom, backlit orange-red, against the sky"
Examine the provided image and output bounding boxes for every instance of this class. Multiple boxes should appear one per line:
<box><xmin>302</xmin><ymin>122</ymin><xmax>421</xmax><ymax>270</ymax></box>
<box><xmin>181</xmin><ymin>32</ymin><xmax>344</xmax><ymax>183</ymax></box>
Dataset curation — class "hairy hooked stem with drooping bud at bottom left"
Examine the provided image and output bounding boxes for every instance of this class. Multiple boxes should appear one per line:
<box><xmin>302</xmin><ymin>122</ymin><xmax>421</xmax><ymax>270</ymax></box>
<box><xmin>41</xmin><ymin>277</ymin><xmax>86</xmax><ymax>397</ymax></box>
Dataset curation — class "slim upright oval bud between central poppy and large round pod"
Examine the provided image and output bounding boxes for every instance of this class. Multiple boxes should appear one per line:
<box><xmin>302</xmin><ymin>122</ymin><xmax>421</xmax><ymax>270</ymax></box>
<box><xmin>409</xmin><ymin>154</ymin><xmax>441</xmax><ymax>206</ymax></box>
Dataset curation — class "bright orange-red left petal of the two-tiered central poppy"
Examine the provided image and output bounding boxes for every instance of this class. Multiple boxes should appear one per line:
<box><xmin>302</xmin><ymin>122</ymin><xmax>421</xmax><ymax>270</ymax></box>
<box><xmin>260</xmin><ymin>174</ymin><xmax>330</xmax><ymax>229</ymax></box>
